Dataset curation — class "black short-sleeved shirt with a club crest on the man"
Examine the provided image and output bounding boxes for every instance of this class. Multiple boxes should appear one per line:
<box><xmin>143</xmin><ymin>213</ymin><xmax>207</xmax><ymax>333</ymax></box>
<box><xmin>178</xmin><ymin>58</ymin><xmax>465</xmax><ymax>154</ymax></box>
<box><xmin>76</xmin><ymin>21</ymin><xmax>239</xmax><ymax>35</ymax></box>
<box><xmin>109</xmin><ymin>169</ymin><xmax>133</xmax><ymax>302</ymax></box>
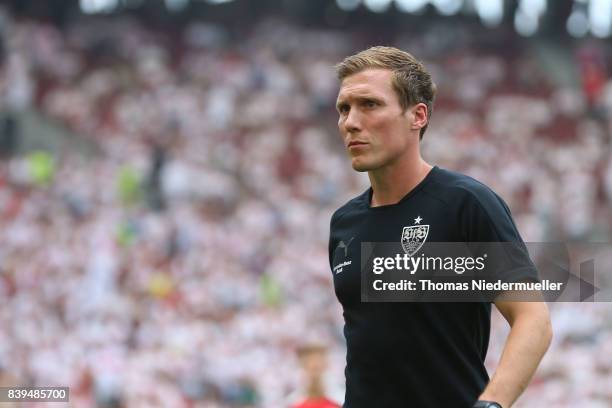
<box><xmin>329</xmin><ymin>167</ymin><xmax>537</xmax><ymax>408</ymax></box>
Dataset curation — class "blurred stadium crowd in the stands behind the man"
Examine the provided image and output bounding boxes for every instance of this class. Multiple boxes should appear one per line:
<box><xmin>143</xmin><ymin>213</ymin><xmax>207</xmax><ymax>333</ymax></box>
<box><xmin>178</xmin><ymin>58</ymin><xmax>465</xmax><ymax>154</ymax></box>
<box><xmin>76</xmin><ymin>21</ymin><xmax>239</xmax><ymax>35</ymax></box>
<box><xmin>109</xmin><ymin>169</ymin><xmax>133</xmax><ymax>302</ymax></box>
<box><xmin>0</xmin><ymin>0</ymin><xmax>612</xmax><ymax>408</ymax></box>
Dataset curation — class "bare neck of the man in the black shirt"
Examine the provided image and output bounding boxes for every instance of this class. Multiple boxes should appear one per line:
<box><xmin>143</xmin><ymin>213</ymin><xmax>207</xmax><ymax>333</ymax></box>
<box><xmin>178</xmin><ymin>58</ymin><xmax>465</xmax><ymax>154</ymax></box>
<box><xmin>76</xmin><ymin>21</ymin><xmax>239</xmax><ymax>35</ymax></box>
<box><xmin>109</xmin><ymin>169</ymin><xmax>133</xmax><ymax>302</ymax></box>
<box><xmin>368</xmin><ymin>155</ymin><xmax>432</xmax><ymax>207</ymax></box>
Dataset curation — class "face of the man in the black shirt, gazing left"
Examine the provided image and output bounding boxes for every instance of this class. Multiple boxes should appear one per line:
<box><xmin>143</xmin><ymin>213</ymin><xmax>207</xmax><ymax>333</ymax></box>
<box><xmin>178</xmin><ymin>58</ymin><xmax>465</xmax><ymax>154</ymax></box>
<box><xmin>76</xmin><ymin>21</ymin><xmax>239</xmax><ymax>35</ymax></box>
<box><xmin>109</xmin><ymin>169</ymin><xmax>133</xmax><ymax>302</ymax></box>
<box><xmin>336</xmin><ymin>68</ymin><xmax>418</xmax><ymax>171</ymax></box>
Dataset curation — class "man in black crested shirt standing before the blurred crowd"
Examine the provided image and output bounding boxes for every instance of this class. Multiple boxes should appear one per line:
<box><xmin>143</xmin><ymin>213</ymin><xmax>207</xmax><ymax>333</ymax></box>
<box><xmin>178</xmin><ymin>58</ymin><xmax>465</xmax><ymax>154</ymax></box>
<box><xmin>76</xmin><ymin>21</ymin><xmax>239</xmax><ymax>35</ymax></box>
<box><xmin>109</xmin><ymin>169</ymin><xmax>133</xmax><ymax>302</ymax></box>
<box><xmin>329</xmin><ymin>47</ymin><xmax>552</xmax><ymax>408</ymax></box>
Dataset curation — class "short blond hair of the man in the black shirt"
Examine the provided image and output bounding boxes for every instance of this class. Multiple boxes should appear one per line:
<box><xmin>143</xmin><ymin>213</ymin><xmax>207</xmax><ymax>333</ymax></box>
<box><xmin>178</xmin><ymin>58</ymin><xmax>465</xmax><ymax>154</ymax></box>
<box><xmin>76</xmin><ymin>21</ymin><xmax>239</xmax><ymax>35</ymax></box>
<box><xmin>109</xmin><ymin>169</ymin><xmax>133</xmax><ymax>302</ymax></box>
<box><xmin>335</xmin><ymin>46</ymin><xmax>436</xmax><ymax>139</ymax></box>
